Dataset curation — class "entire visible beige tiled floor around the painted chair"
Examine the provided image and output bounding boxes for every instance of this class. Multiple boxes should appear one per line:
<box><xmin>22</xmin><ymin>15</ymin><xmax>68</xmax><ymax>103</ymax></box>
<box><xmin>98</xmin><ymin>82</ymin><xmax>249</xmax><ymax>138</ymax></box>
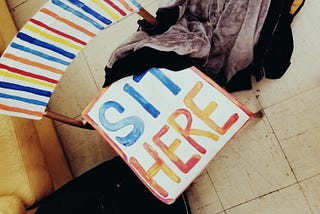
<box><xmin>8</xmin><ymin>0</ymin><xmax>320</xmax><ymax>214</ymax></box>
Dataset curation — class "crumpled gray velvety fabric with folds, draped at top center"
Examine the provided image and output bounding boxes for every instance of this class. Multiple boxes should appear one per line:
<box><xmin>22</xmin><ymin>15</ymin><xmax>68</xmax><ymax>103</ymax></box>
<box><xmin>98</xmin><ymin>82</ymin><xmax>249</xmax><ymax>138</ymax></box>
<box><xmin>107</xmin><ymin>0</ymin><xmax>271</xmax><ymax>80</ymax></box>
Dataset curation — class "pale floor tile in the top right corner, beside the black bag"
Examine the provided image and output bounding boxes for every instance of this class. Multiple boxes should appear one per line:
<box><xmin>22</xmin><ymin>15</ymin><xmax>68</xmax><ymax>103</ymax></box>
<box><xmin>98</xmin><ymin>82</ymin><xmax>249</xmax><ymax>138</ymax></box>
<box><xmin>256</xmin><ymin>0</ymin><xmax>320</xmax><ymax>107</ymax></box>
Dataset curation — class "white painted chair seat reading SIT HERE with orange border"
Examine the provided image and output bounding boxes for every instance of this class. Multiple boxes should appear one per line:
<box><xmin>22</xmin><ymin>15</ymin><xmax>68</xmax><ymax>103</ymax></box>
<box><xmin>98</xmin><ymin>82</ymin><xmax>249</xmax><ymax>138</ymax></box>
<box><xmin>82</xmin><ymin>67</ymin><xmax>252</xmax><ymax>204</ymax></box>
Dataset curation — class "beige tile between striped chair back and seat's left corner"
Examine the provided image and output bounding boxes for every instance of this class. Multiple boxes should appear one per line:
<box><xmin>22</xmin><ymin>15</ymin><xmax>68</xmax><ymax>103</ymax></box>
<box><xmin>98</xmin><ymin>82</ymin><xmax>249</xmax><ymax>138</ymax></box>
<box><xmin>49</xmin><ymin>53</ymin><xmax>98</xmax><ymax>118</ymax></box>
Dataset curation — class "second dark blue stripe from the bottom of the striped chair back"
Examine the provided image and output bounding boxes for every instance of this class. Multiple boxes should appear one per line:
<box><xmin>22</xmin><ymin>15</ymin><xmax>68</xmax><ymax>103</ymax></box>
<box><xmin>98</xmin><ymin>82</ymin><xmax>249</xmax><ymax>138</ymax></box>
<box><xmin>17</xmin><ymin>32</ymin><xmax>76</xmax><ymax>59</ymax></box>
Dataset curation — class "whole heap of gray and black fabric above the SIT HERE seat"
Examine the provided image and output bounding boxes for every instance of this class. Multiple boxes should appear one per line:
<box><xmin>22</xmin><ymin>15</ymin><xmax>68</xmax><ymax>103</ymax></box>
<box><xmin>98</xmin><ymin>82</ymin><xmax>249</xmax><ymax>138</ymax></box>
<box><xmin>104</xmin><ymin>0</ymin><xmax>304</xmax><ymax>92</ymax></box>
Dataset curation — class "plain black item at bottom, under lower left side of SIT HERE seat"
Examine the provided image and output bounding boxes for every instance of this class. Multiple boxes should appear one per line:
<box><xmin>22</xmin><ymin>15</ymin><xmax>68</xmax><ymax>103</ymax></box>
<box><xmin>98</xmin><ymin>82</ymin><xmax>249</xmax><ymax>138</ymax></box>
<box><xmin>36</xmin><ymin>157</ymin><xmax>191</xmax><ymax>214</ymax></box>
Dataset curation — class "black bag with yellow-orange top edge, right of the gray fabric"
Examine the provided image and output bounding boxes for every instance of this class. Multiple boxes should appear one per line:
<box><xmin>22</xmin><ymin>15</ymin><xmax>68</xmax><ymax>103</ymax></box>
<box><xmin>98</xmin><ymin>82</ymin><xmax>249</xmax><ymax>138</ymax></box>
<box><xmin>225</xmin><ymin>0</ymin><xmax>305</xmax><ymax>92</ymax></box>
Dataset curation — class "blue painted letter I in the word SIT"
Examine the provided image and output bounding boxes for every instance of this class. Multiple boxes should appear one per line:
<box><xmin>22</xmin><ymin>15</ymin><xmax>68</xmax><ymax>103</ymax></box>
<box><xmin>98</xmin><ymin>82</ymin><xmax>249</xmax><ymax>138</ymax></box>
<box><xmin>123</xmin><ymin>84</ymin><xmax>160</xmax><ymax>118</ymax></box>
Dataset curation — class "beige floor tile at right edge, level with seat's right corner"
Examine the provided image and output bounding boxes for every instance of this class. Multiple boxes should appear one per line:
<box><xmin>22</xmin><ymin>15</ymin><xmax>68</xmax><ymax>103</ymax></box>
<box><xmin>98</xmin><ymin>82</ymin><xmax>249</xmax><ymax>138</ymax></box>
<box><xmin>265</xmin><ymin>87</ymin><xmax>320</xmax><ymax>141</ymax></box>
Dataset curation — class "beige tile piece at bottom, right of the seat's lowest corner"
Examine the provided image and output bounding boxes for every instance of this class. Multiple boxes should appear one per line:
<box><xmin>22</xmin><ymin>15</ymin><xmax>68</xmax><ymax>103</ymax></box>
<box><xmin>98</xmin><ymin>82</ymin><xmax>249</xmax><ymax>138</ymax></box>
<box><xmin>186</xmin><ymin>171</ymin><xmax>223</xmax><ymax>214</ymax></box>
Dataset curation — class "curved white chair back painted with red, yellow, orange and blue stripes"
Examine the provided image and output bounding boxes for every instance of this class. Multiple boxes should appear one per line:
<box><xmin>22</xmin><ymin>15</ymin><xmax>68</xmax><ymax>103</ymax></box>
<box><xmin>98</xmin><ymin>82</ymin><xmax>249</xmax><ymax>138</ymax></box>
<box><xmin>0</xmin><ymin>0</ymin><xmax>142</xmax><ymax>119</ymax></box>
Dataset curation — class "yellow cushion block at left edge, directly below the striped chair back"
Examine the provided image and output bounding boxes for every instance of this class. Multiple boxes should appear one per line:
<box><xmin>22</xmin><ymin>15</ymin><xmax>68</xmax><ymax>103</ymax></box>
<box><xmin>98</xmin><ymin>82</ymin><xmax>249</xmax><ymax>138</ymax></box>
<box><xmin>0</xmin><ymin>115</ymin><xmax>53</xmax><ymax>207</ymax></box>
